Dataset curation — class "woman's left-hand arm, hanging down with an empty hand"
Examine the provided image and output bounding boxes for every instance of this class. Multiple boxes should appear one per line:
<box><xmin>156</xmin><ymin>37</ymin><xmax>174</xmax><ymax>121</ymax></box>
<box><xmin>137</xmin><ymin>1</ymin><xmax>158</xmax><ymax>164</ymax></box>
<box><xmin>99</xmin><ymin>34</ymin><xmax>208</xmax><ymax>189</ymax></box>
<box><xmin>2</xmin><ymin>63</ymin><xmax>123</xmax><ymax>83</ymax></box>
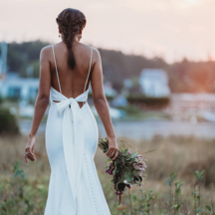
<box><xmin>25</xmin><ymin>47</ymin><xmax>51</xmax><ymax>163</ymax></box>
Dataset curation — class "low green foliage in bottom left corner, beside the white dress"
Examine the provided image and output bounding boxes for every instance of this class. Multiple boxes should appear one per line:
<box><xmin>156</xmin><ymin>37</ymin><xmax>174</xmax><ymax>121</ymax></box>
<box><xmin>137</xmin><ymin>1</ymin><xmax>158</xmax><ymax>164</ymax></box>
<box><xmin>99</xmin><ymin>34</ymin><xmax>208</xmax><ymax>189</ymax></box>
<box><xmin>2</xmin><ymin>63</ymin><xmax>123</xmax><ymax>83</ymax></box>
<box><xmin>0</xmin><ymin>161</ymin><xmax>48</xmax><ymax>215</ymax></box>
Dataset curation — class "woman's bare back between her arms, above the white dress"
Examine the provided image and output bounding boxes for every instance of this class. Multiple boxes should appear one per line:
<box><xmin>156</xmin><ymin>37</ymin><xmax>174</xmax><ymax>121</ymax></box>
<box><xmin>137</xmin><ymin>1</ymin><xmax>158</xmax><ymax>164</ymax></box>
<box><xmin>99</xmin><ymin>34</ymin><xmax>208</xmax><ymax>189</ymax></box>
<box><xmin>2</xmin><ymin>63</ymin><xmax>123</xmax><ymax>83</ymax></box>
<box><xmin>50</xmin><ymin>42</ymin><xmax>93</xmax><ymax>107</ymax></box>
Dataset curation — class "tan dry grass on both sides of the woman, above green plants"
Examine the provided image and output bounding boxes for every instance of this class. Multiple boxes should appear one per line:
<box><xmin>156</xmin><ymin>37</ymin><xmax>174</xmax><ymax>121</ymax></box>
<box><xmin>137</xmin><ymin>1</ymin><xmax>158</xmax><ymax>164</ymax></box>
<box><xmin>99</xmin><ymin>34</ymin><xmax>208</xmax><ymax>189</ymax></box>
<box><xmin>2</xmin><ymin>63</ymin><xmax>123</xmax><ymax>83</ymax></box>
<box><xmin>0</xmin><ymin>136</ymin><xmax>215</xmax><ymax>213</ymax></box>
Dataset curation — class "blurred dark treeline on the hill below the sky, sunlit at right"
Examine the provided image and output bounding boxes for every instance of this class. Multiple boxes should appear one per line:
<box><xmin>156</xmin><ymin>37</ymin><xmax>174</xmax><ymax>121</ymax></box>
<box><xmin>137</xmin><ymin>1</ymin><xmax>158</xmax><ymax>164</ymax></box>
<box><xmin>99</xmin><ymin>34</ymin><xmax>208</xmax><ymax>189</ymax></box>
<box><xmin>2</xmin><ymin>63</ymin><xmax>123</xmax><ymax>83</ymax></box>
<box><xmin>3</xmin><ymin>40</ymin><xmax>215</xmax><ymax>93</ymax></box>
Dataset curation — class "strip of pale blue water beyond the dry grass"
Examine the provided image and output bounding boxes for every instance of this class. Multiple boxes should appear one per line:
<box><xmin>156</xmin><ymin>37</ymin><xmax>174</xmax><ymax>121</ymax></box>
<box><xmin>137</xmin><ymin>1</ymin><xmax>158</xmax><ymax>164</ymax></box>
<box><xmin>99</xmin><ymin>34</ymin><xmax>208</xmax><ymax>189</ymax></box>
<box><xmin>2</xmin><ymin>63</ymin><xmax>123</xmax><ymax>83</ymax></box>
<box><xmin>19</xmin><ymin>120</ymin><xmax>215</xmax><ymax>140</ymax></box>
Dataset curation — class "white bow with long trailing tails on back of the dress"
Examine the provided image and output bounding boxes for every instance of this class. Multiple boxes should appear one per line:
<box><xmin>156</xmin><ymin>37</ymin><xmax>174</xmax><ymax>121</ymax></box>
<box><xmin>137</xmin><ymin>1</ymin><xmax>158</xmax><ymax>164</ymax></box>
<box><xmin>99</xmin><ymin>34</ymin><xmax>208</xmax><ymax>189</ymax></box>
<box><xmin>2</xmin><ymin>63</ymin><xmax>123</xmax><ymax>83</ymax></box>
<box><xmin>51</xmin><ymin>87</ymin><xmax>89</xmax><ymax>207</ymax></box>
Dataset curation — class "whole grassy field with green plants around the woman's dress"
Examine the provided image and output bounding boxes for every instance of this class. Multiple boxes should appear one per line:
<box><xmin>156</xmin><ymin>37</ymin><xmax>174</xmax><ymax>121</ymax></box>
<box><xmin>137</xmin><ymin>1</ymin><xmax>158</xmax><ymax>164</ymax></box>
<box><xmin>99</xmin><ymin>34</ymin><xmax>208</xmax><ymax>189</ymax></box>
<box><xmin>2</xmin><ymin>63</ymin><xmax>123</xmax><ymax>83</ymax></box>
<box><xmin>0</xmin><ymin>135</ymin><xmax>215</xmax><ymax>215</ymax></box>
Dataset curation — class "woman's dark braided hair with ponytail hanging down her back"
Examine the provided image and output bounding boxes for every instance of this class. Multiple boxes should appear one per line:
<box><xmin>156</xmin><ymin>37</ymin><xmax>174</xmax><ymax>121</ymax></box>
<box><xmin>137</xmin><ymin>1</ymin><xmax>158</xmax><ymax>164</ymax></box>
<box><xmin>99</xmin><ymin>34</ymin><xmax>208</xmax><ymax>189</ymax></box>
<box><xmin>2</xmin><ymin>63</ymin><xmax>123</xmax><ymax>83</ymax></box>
<box><xmin>56</xmin><ymin>8</ymin><xmax>87</xmax><ymax>69</ymax></box>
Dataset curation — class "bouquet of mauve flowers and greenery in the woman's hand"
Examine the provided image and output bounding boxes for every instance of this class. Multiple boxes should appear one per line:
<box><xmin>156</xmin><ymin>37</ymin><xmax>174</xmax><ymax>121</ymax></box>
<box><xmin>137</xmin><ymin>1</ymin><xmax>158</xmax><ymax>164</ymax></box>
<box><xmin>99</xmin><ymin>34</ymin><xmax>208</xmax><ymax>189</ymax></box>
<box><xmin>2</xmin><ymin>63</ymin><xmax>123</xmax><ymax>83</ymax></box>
<box><xmin>98</xmin><ymin>138</ymin><xmax>147</xmax><ymax>205</ymax></box>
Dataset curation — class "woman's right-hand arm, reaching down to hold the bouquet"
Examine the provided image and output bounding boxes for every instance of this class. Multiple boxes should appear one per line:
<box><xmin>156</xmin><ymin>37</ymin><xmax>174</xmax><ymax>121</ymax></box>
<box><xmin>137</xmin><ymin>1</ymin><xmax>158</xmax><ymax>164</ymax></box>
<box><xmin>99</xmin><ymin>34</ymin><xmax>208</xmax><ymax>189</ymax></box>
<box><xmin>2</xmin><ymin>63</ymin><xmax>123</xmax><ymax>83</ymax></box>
<box><xmin>91</xmin><ymin>48</ymin><xmax>118</xmax><ymax>160</ymax></box>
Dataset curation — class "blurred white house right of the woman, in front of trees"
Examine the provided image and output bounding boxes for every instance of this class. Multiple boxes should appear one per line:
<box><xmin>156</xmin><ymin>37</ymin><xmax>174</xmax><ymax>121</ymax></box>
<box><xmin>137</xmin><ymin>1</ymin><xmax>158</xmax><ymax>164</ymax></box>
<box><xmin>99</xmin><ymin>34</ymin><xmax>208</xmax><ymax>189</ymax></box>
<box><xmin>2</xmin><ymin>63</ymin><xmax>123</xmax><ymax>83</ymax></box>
<box><xmin>139</xmin><ymin>69</ymin><xmax>170</xmax><ymax>97</ymax></box>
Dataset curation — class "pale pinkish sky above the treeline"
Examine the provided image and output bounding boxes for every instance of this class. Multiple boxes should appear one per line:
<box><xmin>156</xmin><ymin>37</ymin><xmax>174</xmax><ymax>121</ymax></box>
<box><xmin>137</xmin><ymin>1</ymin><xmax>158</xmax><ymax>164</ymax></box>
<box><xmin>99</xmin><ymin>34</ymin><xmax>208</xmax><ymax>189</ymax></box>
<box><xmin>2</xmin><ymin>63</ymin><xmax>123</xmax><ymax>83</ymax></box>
<box><xmin>0</xmin><ymin>0</ymin><xmax>215</xmax><ymax>63</ymax></box>
